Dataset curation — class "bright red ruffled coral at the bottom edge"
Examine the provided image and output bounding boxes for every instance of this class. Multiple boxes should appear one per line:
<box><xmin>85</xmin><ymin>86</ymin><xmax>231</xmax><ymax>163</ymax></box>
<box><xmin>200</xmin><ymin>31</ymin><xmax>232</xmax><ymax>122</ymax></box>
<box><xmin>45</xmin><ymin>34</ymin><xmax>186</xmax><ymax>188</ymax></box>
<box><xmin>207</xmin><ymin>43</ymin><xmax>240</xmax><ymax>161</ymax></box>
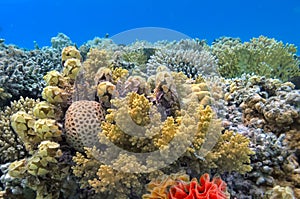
<box><xmin>168</xmin><ymin>173</ymin><xmax>229</xmax><ymax>199</ymax></box>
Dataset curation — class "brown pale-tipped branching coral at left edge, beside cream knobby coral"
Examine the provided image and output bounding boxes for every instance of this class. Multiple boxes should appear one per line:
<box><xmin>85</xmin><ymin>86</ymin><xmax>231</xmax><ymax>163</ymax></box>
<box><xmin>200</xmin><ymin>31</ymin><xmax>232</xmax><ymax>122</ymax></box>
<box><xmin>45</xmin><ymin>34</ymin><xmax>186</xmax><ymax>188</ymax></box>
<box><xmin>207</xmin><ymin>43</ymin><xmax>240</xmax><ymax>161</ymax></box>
<box><xmin>0</xmin><ymin>97</ymin><xmax>39</xmax><ymax>164</ymax></box>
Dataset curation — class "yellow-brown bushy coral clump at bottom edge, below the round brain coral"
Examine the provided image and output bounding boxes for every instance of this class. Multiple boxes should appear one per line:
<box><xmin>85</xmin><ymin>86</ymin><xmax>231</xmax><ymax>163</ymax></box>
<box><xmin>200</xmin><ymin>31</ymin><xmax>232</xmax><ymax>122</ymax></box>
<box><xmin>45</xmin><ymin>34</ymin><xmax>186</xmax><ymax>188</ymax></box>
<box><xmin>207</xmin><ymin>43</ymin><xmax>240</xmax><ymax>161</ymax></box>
<box><xmin>72</xmin><ymin>148</ymin><xmax>143</xmax><ymax>198</ymax></box>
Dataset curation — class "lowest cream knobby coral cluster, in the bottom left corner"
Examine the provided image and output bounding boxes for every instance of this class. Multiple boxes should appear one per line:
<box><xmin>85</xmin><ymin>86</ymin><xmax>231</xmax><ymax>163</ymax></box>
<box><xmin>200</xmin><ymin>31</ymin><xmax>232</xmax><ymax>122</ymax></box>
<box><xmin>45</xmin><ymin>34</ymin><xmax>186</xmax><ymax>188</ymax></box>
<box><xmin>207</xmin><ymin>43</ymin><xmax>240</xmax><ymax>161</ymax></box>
<box><xmin>8</xmin><ymin>141</ymin><xmax>69</xmax><ymax>199</ymax></box>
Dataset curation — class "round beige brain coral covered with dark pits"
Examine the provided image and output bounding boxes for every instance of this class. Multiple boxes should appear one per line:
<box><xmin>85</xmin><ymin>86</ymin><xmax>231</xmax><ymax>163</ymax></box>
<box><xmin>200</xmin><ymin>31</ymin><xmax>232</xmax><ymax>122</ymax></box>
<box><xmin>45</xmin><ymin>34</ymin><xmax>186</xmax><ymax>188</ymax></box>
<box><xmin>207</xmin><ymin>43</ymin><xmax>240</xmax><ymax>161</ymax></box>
<box><xmin>65</xmin><ymin>100</ymin><xmax>105</xmax><ymax>151</ymax></box>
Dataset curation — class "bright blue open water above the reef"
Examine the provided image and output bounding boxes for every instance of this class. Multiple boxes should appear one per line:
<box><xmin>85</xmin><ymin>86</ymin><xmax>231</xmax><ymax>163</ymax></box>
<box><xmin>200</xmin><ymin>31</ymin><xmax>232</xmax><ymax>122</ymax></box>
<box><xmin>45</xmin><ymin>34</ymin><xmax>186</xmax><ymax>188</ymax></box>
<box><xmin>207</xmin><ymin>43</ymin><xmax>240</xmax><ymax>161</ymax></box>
<box><xmin>0</xmin><ymin>0</ymin><xmax>300</xmax><ymax>49</ymax></box>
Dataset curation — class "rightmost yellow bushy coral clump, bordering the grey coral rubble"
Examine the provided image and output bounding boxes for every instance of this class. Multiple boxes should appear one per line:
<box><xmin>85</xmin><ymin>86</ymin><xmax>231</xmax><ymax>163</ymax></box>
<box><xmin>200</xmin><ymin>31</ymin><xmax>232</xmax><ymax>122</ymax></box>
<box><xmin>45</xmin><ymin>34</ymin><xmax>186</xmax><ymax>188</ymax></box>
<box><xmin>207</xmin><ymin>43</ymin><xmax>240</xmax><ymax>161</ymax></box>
<box><xmin>205</xmin><ymin>131</ymin><xmax>254</xmax><ymax>173</ymax></box>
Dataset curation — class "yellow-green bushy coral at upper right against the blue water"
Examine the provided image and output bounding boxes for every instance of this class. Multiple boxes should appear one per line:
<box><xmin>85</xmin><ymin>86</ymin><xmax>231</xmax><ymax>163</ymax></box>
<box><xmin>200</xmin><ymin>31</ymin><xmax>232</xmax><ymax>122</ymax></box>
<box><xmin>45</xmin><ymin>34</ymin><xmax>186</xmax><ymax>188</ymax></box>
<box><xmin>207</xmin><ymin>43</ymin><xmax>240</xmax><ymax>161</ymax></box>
<box><xmin>212</xmin><ymin>36</ymin><xmax>300</xmax><ymax>81</ymax></box>
